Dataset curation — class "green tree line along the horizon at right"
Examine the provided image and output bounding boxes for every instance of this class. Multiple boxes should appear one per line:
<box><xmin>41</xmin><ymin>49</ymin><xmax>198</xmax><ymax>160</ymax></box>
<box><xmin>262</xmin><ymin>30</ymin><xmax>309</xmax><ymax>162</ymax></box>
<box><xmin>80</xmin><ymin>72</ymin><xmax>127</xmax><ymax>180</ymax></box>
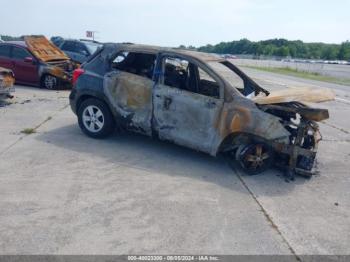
<box><xmin>194</xmin><ymin>39</ymin><xmax>350</xmax><ymax>61</ymax></box>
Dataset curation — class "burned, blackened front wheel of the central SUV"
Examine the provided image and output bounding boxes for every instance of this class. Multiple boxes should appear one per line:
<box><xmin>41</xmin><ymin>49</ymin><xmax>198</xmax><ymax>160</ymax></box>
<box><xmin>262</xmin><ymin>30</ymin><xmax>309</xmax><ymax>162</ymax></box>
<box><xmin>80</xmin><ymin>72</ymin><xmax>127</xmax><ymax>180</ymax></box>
<box><xmin>238</xmin><ymin>143</ymin><xmax>273</xmax><ymax>175</ymax></box>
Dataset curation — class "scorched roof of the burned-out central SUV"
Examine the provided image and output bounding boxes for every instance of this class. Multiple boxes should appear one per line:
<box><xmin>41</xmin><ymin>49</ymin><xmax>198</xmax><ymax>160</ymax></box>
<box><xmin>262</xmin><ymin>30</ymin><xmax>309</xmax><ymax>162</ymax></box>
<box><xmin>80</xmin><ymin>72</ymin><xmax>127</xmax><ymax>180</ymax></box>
<box><xmin>118</xmin><ymin>44</ymin><xmax>225</xmax><ymax>62</ymax></box>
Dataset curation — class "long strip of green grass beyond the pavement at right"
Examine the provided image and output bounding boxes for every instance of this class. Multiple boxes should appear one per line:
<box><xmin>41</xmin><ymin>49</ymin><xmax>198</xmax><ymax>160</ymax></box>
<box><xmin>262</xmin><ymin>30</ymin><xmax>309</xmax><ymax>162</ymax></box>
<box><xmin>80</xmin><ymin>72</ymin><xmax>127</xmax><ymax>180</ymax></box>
<box><xmin>245</xmin><ymin>66</ymin><xmax>350</xmax><ymax>86</ymax></box>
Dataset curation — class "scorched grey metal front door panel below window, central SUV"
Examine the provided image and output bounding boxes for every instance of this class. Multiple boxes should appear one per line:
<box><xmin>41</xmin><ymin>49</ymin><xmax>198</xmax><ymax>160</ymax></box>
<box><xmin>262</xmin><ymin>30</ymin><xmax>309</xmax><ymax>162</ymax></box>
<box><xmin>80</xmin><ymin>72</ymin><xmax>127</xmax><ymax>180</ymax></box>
<box><xmin>153</xmin><ymin>85</ymin><xmax>223</xmax><ymax>155</ymax></box>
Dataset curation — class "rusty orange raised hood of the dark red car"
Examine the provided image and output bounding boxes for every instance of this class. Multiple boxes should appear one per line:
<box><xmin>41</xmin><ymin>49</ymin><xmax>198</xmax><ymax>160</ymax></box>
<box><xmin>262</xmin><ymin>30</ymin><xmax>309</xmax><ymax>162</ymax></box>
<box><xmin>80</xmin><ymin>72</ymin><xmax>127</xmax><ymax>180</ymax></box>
<box><xmin>24</xmin><ymin>36</ymin><xmax>69</xmax><ymax>62</ymax></box>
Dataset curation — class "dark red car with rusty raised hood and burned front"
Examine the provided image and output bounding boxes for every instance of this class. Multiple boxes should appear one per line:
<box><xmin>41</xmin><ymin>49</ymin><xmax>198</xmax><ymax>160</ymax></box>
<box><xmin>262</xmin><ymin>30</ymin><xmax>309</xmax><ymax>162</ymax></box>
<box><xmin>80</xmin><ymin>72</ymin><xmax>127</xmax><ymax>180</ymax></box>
<box><xmin>0</xmin><ymin>37</ymin><xmax>77</xmax><ymax>89</ymax></box>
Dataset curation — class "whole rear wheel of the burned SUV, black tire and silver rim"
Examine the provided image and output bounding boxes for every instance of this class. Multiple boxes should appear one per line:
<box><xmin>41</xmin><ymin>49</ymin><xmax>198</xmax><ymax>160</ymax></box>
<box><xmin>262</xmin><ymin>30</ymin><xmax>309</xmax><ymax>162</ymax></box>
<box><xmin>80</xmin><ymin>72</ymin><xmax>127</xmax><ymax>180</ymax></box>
<box><xmin>77</xmin><ymin>98</ymin><xmax>115</xmax><ymax>138</ymax></box>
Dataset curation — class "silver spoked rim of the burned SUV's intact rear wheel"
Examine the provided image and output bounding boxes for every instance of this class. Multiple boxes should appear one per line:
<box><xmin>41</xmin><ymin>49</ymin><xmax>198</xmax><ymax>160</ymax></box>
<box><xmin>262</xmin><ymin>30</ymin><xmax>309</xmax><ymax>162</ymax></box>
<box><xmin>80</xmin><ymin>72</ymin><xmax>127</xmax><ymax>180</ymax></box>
<box><xmin>82</xmin><ymin>105</ymin><xmax>105</xmax><ymax>133</ymax></box>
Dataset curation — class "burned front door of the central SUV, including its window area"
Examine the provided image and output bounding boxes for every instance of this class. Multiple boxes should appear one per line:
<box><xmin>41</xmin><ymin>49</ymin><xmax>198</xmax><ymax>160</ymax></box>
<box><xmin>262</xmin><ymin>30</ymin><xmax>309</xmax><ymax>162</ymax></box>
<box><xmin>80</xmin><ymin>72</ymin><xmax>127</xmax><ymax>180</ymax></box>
<box><xmin>153</xmin><ymin>54</ymin><xmax>223</xmax><ymax>153</ymax></box>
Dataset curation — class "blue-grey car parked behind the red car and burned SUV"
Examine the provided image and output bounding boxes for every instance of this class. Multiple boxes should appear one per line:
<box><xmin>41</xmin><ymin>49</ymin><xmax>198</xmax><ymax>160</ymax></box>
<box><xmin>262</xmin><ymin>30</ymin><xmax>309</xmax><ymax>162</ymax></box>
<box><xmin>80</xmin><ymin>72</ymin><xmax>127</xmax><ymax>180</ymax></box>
<box><xmin>51</xmin><ymin>36</ymin><xmax>102</xmax><ymax>64</ymax></box>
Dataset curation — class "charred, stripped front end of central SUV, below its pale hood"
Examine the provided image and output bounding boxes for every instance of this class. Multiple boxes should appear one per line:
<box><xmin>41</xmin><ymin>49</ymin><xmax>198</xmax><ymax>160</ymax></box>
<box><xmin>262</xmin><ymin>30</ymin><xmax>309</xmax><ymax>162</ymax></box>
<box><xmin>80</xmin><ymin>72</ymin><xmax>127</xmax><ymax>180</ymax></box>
<box><xmin>259</xmin><ymin>102</ymin><xmax>329</xmax><ymax>177</ymax></box>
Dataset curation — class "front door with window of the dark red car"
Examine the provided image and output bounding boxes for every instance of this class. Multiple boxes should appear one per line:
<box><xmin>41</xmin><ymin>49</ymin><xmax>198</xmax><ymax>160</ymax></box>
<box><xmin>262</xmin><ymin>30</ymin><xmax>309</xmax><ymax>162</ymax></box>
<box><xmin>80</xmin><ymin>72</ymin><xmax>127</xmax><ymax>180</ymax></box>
<box><xmin>11</xmin><ymin>46</ymin><xmax>39</xmax><ymax>84</ymax></box>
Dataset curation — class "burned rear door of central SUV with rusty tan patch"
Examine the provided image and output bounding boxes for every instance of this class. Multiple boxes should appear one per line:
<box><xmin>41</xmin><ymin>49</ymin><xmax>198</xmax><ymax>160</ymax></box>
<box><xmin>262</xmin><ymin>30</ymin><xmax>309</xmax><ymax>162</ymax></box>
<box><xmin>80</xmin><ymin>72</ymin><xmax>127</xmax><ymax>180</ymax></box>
<box><xmin>104</xmin><ymin>52</ymin><xmax>155</xmax><ymax>136</ymax></box>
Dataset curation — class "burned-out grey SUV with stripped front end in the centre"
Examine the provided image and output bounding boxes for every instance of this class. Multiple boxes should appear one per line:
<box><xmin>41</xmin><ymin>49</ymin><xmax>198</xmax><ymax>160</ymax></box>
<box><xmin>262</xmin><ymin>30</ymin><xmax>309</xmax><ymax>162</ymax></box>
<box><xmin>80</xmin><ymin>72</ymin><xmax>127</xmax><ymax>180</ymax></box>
<box><xmin>70</xmin><ymin>44</ymin><xmax>334</xmax><ymax>176</ymax></box>
